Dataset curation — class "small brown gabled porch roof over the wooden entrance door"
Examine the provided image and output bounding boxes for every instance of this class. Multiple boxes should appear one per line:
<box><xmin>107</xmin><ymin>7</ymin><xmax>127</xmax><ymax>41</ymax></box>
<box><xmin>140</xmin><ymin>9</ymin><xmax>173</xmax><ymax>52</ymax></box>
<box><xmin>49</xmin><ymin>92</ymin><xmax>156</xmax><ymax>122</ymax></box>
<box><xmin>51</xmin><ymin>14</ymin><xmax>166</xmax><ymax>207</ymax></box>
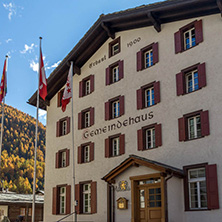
<box><xmin>102</xmin><ymin>155</ymin><xmax>184</xmax><ymax>182</ymax></box>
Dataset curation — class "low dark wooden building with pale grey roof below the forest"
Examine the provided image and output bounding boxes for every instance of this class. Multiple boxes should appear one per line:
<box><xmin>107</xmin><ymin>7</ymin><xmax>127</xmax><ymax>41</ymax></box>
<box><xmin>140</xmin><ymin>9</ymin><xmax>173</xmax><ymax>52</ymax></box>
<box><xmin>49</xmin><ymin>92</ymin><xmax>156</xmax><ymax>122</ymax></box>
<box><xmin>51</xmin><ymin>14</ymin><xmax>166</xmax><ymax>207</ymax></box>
<box><xmin>0</xmin><ymin>191</ymin><xmax>44</xmax><ymax>222</ymax></box>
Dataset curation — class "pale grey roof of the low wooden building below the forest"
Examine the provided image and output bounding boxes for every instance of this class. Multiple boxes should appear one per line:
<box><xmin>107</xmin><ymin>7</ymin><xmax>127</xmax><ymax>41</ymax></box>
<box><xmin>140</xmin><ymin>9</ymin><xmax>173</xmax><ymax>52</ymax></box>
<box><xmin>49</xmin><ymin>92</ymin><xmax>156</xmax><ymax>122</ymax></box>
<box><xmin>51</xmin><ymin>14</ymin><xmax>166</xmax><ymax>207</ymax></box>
<box><xmin>0</xmin><ymin>193</ymin><xmax>44</xmax><ymax>204</ymax></box>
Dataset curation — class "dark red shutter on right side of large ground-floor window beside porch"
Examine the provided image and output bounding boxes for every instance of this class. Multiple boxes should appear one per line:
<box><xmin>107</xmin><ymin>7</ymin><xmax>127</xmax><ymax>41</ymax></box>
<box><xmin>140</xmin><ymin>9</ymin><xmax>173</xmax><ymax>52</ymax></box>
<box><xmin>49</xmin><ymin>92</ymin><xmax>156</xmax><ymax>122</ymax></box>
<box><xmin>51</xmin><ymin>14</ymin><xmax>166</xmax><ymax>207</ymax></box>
<box><xmin>206</xmin><ymin>164</ymin><xmax>219</xmax><ymax>210</ymax></box>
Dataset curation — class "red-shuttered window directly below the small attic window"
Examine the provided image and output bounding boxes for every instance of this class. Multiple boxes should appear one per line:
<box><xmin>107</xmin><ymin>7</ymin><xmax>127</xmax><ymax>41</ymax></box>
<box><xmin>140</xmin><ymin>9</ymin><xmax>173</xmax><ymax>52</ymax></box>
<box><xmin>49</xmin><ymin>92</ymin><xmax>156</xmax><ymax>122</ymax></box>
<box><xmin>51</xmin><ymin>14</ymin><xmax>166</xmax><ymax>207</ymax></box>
<box><xmin>106</xmin><ymin>60</ymin><xmax>123</xmax><ymax>85</ymax></box>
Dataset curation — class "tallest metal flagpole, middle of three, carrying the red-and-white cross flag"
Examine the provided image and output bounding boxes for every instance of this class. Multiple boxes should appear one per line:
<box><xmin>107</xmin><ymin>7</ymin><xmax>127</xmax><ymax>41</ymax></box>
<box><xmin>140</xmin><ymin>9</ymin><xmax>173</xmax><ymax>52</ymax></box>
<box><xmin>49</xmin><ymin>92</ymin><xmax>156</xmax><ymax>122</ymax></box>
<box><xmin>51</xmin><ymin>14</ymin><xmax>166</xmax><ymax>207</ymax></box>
<box><xmin>32</xmin><ymin>37</ymin><xmax>42</xmax><ymax>222</ymax></box>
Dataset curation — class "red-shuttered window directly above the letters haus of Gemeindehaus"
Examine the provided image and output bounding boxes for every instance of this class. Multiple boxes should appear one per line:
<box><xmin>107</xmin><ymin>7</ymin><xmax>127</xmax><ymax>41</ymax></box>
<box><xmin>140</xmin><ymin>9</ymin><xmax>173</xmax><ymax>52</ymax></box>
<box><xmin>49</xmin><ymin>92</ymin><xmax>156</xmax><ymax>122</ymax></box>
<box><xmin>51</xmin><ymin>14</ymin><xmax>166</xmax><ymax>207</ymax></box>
<box><xmin>137</xmin><ymin>81</ymin><xmax>160</xmax><ymax>110</ymax></box>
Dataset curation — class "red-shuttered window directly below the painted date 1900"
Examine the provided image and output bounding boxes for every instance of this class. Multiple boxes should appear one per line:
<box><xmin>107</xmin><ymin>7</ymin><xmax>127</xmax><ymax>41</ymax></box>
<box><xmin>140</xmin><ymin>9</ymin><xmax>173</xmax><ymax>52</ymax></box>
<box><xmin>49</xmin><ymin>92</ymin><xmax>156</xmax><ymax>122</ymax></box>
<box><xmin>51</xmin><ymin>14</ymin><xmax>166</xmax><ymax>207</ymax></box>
<box><xmin>137</xmin><ymin>42</ymin><xmax>159</xmax><ymax>71</ymax></box>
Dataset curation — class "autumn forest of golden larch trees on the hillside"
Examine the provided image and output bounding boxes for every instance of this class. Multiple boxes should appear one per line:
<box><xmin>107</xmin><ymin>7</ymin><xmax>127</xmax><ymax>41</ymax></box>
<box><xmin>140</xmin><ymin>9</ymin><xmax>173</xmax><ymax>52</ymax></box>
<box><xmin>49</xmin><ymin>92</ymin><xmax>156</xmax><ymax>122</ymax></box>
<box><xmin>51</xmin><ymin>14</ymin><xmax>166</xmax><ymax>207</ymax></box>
<box><xmin>0</xmin><ymin>105</ymin><xmax>46</xmax><ymax>193</ymax></box>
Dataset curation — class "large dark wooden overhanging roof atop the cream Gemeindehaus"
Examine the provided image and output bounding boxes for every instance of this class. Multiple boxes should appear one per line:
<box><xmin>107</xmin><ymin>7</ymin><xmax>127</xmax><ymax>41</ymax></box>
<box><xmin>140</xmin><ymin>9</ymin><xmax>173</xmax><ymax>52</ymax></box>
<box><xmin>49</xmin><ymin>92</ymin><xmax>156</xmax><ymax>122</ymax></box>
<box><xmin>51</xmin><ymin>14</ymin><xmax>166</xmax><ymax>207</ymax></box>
<box><xmin>28</xmin><ymin>0</ymin><xmax>222</xmax><ymax>110</ymax></box>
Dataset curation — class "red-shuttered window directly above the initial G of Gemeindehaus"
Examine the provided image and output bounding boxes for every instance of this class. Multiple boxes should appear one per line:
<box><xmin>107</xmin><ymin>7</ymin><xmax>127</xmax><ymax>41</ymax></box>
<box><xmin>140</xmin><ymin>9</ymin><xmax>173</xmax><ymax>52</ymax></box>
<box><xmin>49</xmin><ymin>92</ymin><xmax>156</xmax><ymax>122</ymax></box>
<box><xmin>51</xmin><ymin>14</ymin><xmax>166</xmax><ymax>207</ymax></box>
<box><xmin>78</xmin><ymin>107</ymin><xmax>94</xmax><ymax>129</ymax></box>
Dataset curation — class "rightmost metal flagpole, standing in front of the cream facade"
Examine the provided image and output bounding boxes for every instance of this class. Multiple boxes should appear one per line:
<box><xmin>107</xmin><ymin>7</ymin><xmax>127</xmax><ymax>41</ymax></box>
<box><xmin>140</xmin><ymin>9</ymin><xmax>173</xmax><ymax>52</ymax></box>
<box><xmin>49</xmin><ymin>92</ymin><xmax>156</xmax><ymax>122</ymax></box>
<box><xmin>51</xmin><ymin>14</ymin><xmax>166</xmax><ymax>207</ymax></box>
<box><xmin>71</xmin><ymin>61</ymin><xmax>79</xmax><ymax>222</ymax></box>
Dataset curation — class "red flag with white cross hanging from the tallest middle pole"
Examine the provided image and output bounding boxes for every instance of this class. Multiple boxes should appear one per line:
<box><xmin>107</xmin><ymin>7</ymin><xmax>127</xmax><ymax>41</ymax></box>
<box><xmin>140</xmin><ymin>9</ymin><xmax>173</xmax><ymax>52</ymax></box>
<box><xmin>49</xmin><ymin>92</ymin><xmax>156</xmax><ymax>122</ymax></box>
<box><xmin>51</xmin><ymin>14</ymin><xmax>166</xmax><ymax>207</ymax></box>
<box><xmin>39</xmin><ymin>46</ymin><xmax>47</xmax><ymax>100</ymax></box>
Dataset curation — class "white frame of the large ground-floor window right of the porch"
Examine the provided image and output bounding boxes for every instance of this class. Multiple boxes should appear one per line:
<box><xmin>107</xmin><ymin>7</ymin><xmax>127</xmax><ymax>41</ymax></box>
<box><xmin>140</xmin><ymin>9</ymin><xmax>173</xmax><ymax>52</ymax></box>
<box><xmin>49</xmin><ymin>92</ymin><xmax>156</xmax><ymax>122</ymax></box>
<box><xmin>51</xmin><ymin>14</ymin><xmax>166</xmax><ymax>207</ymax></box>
<box><xmin>188</xmin><ymin>167</ymin><xmax>207</xmax><ymax>209</ymax></box>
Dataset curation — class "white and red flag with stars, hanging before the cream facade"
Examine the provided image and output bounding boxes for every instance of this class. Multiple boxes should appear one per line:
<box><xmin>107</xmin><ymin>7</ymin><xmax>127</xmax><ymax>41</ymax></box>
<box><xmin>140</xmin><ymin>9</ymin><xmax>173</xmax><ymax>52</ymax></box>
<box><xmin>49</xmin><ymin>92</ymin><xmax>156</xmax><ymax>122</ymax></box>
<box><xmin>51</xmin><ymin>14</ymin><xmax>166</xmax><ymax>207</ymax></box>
<box><xmin>62</xmin><ymin>63</ymin><xmax>73</xmax><ymax>112</ymax></box>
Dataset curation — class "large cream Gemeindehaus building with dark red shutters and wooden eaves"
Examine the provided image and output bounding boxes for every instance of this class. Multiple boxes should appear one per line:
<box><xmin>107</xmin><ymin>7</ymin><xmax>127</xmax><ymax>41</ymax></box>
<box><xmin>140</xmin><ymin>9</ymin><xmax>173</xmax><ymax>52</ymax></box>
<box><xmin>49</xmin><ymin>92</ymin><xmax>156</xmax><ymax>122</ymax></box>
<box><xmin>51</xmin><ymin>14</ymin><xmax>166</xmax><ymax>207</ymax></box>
<box><xmin>29</xmin><ymin>0</ymin><xmax>222</xmax><ymax>222</ymax></box>
